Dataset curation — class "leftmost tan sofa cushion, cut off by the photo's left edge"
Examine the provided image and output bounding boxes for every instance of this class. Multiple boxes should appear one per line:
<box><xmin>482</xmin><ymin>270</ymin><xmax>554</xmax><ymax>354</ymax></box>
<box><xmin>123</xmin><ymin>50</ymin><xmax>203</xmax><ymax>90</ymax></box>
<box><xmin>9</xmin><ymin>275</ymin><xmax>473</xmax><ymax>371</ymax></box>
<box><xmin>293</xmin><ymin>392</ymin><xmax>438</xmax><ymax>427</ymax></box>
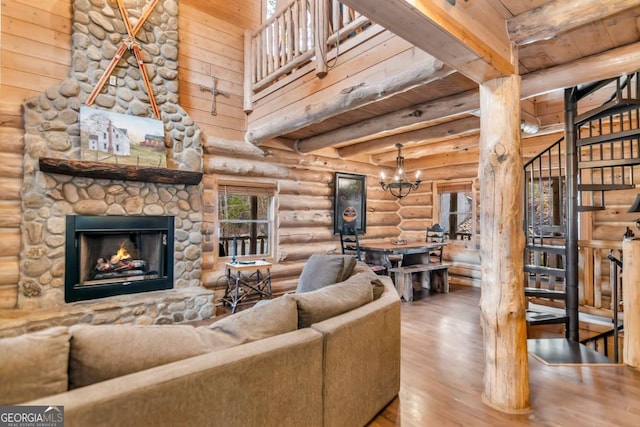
<box><xmin>0</xmin><ymin>326</ymin><xmax>71</xmax><ymax>405</ymax></box>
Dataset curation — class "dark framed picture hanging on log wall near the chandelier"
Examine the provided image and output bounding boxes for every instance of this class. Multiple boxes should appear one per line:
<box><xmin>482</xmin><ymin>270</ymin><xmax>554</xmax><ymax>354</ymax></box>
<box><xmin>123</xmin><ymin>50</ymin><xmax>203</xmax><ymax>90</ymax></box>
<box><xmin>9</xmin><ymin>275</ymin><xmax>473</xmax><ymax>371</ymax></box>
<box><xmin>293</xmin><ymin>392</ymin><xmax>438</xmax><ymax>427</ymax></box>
<box><xmin>333</xmin><ymin>172</ymin><xmax>367</xmax><ymax>234</ymax></box>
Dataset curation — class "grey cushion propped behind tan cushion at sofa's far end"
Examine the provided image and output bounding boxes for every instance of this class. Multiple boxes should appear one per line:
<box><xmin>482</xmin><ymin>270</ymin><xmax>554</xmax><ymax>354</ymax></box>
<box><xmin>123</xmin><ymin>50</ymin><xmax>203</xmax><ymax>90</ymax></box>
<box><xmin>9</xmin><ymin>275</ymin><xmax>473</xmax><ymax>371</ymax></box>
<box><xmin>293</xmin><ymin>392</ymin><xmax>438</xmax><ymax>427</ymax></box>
<box><xmin>296</xmin><ymin>254</ymin><xmax>356</xmax><ymax>293</ymax></box>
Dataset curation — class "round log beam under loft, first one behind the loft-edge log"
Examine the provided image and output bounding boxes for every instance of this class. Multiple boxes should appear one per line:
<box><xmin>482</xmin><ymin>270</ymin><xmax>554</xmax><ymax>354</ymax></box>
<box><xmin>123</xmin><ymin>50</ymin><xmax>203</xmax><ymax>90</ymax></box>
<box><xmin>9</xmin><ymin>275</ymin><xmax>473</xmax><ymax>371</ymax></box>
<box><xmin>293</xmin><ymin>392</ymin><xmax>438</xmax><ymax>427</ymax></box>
<box><xmin>296</xmin><ymin>90</ymin><xmax>480</xmax><ymax>153</ymax></box>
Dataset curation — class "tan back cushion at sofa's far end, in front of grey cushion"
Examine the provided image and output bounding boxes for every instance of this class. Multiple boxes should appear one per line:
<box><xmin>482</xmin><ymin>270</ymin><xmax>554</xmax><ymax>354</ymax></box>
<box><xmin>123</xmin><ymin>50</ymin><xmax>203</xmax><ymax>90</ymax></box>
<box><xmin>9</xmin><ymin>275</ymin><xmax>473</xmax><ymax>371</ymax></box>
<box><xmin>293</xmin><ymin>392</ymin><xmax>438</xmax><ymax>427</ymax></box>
<box><xmin>290</xmin><ymin>272</ymin><xmax>373</xmax><ymax>328</ymax></box>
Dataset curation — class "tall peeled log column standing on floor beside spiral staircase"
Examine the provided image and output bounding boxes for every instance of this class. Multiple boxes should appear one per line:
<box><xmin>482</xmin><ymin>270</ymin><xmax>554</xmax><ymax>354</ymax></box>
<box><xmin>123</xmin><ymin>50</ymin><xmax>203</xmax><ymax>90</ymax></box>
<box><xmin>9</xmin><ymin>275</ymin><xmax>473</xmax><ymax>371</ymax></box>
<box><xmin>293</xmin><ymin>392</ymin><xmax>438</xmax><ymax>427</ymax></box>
<box><xmin>478</xmin><ymin>75</ymin><xmax>529</xmax><ymax>413</ymax></box>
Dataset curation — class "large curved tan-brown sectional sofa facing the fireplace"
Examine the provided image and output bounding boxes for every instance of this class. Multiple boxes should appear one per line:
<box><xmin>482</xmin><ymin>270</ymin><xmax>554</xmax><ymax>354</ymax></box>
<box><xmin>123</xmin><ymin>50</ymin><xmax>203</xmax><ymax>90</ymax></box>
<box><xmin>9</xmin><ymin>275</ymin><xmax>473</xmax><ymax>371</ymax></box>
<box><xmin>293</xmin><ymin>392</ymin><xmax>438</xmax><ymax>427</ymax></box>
<box><xmin>0</xmin><ymin>263</ymin><xmax>400</xmax><ymax>427</ymax></box>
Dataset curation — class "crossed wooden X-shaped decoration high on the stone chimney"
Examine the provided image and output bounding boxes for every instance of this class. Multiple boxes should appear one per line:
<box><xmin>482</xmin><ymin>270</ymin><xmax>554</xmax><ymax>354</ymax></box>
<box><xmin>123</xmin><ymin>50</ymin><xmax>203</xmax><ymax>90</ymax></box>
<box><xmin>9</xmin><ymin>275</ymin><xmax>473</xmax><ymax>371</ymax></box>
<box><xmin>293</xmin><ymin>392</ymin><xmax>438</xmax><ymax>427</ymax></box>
<box><xmin>87</xmin><ymin>0</ymin><xmax>160</xmax><ymax>119</ymax></box>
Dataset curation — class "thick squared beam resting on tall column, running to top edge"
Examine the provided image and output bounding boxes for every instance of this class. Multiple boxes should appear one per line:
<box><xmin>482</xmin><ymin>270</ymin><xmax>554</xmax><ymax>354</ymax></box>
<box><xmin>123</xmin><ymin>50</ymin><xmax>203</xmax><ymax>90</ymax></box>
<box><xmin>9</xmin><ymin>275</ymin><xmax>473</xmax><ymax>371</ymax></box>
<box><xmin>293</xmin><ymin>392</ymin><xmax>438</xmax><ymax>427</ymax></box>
<box><xmin>343</xmin><ymin>0</ymin><xmax>516</xmax><ymax>83</ymax></box>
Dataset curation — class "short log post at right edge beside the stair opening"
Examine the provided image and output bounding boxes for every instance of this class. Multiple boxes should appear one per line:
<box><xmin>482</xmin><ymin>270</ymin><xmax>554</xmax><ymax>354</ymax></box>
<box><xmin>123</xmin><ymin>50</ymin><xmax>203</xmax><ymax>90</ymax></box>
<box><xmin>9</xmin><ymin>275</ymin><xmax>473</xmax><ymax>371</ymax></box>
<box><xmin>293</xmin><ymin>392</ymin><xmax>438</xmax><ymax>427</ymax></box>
<box><xmin>622</xmin><ymin>240</ymin><xmax>640</xmax><ymax>369</ymax></box>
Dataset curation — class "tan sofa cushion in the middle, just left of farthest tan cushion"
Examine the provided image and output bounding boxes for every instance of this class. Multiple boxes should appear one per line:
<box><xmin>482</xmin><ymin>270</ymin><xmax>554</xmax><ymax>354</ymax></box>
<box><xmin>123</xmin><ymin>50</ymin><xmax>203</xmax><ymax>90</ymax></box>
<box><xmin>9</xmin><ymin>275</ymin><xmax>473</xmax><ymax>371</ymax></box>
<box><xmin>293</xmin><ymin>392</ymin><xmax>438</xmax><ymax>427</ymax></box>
<box><xmin>198</xmin><ymin>295</ymin><xmax>298</xmax><ymax>347</ymax></box>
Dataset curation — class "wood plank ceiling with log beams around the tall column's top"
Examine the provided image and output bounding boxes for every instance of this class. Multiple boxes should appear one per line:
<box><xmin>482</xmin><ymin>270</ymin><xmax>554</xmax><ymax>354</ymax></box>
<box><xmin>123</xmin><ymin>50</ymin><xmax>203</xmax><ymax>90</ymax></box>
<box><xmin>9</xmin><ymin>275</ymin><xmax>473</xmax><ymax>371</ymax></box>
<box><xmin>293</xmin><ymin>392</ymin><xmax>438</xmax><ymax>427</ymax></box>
<box><xmin>246</xmin><ymin>0</ymin><xmax>640</xmax><ymax>169</ymax></box>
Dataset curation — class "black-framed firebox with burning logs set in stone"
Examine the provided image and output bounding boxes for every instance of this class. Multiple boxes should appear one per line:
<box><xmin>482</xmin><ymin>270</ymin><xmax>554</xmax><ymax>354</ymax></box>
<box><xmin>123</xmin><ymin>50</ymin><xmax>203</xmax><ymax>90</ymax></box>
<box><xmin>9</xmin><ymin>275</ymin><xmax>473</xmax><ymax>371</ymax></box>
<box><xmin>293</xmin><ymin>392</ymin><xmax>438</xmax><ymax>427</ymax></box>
<box><xmin>65</xmin><ymin>215</ymin><xmax>174</xmax><ymax>302</ymax></box>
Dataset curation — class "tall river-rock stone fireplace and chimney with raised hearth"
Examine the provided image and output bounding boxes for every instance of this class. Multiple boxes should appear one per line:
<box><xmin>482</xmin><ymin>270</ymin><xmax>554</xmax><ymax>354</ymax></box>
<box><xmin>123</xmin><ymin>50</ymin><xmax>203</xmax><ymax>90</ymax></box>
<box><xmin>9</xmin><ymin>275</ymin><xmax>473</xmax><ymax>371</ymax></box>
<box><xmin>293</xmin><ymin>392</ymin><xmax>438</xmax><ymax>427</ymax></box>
<box><xmin>1</xmin><ymin>0</ymin><xmax>213</xmax><ymax>336</ymax></box>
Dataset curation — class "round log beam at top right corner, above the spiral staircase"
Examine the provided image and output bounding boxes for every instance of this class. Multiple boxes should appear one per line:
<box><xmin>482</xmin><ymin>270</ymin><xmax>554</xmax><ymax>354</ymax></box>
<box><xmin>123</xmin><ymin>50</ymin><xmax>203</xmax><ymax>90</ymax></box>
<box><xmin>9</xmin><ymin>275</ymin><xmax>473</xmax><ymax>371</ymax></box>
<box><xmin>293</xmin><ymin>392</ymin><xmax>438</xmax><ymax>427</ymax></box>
<box><xmin>507</xmin><ymin>0</ymin><xmax>640</xmax><ymax>46</ymax></box>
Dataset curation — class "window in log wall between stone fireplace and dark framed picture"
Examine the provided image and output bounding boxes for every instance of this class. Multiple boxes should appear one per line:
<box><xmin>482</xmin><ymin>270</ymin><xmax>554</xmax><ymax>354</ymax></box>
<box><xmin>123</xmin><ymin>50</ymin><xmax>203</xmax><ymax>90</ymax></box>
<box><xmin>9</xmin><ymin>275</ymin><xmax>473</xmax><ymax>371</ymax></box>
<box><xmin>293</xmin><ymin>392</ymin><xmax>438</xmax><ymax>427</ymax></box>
<box><xmin>218</xmin><ymin>183</ymin><xmax>275</xmax><ymax>258</ymax></box>
